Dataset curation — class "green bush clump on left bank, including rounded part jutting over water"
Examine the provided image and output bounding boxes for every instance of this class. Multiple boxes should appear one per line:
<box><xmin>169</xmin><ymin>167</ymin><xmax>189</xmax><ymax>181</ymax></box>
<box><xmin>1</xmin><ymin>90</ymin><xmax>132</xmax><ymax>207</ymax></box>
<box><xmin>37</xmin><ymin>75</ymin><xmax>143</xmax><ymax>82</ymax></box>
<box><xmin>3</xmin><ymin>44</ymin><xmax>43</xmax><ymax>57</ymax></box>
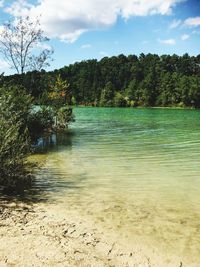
<box><xmin>0</xmin><ymin>86</ymin><xmax>73</xmax><ymax>193</ymax></box>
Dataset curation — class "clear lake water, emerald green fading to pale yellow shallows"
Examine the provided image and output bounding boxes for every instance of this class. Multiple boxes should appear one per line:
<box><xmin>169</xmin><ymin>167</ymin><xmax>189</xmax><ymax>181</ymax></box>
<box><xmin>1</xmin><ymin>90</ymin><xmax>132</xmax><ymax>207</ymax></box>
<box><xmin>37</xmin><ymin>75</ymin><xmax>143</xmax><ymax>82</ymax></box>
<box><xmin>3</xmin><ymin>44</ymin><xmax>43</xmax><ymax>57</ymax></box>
<box><xmin>33</xmin><ymin>108</ymin><xmax>200</xmax><ymax>266</ymax></box>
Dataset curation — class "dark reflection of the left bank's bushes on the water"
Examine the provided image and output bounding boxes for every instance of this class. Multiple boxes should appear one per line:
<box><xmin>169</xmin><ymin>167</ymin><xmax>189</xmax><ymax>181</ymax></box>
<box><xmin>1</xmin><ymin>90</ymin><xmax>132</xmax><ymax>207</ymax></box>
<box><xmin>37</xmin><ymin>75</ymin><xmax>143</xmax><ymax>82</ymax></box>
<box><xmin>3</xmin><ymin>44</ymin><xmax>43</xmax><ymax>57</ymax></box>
<box><xmin>0</xmin><ymin>131</ymin><xmax>77</xmax><ymax>202</ymax></box>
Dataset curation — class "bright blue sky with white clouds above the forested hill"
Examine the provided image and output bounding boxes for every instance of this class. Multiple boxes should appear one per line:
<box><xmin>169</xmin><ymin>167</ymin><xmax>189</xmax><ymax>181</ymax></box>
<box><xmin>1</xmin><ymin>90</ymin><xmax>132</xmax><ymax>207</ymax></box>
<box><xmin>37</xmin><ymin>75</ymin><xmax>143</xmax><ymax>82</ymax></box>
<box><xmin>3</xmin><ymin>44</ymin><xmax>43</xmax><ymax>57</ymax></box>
<box><xmin>0</xmin><ymin>0</ymin><xmax>200</xmax><ymax>74</ymax></box>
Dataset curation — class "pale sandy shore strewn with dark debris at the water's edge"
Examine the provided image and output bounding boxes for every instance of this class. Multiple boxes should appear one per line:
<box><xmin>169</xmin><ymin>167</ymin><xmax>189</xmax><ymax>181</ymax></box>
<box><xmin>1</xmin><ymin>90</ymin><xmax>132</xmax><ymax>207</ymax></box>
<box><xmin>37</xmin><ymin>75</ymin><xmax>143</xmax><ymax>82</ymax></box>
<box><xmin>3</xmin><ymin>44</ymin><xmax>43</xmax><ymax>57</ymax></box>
<box><xmin>0</xmin><ymin>203</ymin><xmax>197</xmax><ymax>267</ymax></box>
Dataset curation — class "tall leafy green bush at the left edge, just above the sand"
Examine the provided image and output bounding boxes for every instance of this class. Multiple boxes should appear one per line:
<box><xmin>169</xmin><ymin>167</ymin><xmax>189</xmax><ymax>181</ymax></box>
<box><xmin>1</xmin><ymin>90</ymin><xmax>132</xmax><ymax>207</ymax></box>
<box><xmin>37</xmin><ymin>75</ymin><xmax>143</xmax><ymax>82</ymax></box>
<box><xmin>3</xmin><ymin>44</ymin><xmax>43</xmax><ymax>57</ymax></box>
<box><xmin>0</xmin><ymin>87</ymin><xmax>30</xmax><ymax>191</ymax></box>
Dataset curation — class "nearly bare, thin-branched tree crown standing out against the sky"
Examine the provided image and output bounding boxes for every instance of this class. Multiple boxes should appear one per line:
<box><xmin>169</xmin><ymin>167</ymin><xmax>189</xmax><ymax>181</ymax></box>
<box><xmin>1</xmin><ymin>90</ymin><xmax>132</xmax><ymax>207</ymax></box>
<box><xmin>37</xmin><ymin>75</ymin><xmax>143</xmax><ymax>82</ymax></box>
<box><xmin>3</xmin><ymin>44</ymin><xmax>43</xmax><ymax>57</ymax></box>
<box><xmin>0</xmin><ymin>16</ymin><xmax>53</xmax><ymax>74</ymax></box>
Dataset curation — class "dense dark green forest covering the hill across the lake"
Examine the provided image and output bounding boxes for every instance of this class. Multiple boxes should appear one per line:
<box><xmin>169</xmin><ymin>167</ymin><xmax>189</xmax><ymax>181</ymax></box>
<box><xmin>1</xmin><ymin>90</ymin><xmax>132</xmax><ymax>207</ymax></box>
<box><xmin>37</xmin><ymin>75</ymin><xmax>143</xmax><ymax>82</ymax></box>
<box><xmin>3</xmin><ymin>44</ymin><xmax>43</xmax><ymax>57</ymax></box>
<box><xmin>2</xmin><ymin>54</ymin><xmax>200</xmax><ymax>108</ymax></box>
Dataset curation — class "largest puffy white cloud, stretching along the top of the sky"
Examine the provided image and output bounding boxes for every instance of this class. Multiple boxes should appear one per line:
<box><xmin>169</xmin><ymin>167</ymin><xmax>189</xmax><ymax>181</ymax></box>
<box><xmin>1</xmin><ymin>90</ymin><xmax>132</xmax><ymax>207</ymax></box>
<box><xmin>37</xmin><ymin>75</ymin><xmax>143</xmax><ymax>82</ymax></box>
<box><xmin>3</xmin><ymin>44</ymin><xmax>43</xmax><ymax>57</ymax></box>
<box><xmin>3</xmin><ymin>0</ymin><xmax>184</xmax><ymax>42</ymax></box>
